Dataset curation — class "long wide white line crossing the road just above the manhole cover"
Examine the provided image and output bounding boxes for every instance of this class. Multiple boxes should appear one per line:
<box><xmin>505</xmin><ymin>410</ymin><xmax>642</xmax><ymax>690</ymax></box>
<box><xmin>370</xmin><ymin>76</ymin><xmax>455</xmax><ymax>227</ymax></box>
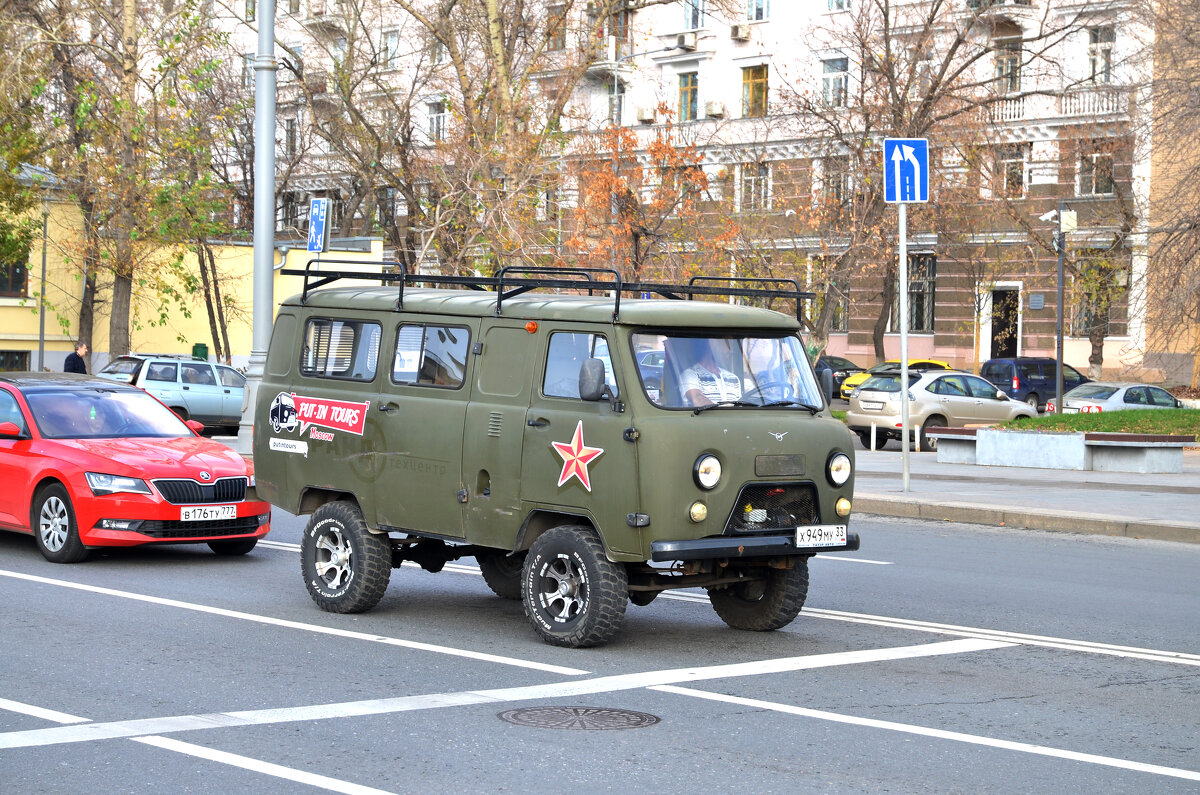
<box><xmin>0</xmin><ymin>639</ymin><xmax>1014</xmax><ymax>748</ymax></box>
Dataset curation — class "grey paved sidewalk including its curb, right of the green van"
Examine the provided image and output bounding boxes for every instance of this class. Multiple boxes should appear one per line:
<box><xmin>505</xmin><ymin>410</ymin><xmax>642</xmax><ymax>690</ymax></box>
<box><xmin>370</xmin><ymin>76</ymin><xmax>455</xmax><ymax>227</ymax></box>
<box><xmin>854</xmin><ymin>442</ymin><xmax>1200</xmax><ymax>543</ymax></box>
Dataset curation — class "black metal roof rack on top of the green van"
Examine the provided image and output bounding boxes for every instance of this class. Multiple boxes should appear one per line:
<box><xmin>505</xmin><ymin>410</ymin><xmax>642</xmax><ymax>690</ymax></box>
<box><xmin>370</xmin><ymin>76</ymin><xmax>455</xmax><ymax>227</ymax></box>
<box><xmin>280</xmin><ymin>259</ymin><xmax>815</xmax><ymax>322</ymax></box>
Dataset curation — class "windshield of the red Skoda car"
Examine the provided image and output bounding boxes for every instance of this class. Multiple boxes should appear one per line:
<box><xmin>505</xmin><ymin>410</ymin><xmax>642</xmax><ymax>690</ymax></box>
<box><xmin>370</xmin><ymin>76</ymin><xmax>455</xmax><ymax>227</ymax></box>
<box><xmin>25</xmin><ymin>388</ymin><xmax>192</xmax><ymax>438</ymax></box>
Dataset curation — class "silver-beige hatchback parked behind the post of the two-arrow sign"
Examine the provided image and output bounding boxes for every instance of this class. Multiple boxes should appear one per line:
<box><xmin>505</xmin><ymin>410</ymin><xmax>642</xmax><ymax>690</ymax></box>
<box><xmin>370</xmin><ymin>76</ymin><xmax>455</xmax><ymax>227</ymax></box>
<box><xmin>846</xmin><ymin>370</ymin><xmax>1038</xmax><ymax>450</ymax></box>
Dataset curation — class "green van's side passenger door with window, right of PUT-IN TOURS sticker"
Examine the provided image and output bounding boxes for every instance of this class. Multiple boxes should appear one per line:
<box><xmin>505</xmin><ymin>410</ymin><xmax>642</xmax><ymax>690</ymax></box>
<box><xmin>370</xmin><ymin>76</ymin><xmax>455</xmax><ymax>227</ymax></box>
<box><xmin>374</xmin><ymin>318</ymin><xmax>479</xmax><ymax>538</ymax></box>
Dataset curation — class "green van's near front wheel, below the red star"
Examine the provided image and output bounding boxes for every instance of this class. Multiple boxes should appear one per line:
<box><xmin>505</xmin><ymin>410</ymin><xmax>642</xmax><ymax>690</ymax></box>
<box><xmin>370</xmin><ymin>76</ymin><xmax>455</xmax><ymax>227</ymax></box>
<box><xmin>521</xmin><ymin>525</ymin><xmax>629</xmax><ymax>648</ymax></box>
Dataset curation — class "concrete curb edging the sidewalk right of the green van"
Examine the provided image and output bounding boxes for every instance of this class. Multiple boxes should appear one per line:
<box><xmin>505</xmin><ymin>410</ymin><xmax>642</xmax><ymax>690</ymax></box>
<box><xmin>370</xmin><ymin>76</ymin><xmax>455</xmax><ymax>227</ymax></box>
<box><xmin>854</xmin><ymin>494</ymin><xmax>1200</xmax><ymax>544</ymax></box>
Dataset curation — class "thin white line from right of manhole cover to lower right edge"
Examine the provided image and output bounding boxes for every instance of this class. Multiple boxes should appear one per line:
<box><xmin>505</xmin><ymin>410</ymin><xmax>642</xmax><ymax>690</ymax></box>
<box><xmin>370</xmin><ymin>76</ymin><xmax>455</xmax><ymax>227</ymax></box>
<box><xmin>650</xmin><ymin>685</ymin><xmax>1200</xmax><ymax>781</ymax></box>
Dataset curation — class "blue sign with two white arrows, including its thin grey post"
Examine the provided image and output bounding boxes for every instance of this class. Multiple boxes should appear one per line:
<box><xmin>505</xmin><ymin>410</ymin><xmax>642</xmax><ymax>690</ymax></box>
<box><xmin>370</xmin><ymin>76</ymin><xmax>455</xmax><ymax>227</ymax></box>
<box><xmin>883</xmin><ymin>138</ymin><xmax>929</xmax><ymax>491</ymax></box>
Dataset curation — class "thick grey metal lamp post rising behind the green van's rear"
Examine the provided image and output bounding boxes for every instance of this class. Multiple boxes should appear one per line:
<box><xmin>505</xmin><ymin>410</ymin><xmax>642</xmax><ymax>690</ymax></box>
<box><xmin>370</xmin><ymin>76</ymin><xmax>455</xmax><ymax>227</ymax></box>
<box><xmin>238</xmin><ymin>0</ymin><xmax>277</xmax><ymax>453</ymax></box>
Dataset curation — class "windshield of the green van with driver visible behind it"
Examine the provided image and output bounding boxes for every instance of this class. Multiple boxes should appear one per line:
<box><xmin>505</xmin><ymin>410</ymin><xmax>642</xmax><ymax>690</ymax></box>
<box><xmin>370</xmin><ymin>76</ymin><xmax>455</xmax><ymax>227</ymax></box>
<box><xmin>632</xmin><ymin>333</ymin><xmax>824</xmax><ymax>410</ymax></box>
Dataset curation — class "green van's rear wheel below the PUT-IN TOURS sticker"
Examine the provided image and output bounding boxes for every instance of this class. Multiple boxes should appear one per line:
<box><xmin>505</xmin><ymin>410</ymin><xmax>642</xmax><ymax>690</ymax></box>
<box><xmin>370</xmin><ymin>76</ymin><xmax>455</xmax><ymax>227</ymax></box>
<box><xmin>300</xmin><ymin>502</ymin><xmax>391</xmax><ymax>612</ymax></box>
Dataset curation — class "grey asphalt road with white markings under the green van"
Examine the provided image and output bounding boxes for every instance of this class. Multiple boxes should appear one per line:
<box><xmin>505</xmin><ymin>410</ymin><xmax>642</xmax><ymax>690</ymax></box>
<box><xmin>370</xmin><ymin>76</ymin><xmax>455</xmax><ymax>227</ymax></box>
<box><xmin>0</xmin><ymin>512</ymin><xmax>1200</xmax><ymax>793</ymax></box>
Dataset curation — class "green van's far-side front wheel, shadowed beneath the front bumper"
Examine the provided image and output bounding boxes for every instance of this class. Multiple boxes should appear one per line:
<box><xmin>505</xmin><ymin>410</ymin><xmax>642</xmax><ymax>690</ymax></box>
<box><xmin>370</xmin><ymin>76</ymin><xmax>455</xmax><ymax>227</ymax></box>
<box><xmin>708</xmin><ymin>557</ymin><xmax>809</xmax><ymax>632</ymax></box>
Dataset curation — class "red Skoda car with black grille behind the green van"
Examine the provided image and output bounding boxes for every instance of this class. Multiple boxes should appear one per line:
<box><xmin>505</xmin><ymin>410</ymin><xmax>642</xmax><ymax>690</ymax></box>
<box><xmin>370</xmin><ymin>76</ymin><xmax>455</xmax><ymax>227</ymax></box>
<box><xmin>0</xmin><ymin>372</ymin><xmax>271</xmax><ymax>563</ymax></box>
